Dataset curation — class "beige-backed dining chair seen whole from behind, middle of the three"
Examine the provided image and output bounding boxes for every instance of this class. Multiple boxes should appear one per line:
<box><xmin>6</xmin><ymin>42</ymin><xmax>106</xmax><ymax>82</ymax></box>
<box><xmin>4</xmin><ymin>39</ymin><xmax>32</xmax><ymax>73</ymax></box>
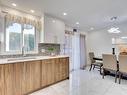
<box><xmin>102</xmin><ymin>54</ymin><xmax>118</xmax><ymax>83</ymax></box>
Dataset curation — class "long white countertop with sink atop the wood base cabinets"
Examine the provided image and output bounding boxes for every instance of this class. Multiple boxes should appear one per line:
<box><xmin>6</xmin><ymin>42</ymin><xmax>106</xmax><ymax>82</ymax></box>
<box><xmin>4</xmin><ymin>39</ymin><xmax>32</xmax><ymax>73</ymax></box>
<box><xmin>0</xmin><ymin>55</ymin><xmax>69</xmax><ymax>64</ymax></box>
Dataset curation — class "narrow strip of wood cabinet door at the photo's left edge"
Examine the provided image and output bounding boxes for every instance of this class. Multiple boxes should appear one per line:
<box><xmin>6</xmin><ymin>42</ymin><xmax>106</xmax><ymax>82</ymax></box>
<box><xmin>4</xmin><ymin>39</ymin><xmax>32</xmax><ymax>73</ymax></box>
<box><xmin>0</xmin><ymin>65</ymin><xmax>5</xmax><ymax>95</ymax></box>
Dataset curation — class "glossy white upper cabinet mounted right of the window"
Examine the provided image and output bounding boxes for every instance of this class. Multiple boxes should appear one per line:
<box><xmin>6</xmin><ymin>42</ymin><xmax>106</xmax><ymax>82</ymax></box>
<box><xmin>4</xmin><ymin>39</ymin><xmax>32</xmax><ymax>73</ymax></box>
<box><xmin>44</xmin><ymin>15</ymin><xmax>65</xmax><ymax>44</ymax></box>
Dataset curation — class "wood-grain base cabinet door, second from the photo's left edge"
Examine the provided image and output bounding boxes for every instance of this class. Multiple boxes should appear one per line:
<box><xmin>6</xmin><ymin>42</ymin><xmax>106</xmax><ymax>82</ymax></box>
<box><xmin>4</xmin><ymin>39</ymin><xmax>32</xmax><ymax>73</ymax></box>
<box><xmin>4</xmin><ymin>63</ymin><xmax>24</xmax><ymax>95</ymax></box>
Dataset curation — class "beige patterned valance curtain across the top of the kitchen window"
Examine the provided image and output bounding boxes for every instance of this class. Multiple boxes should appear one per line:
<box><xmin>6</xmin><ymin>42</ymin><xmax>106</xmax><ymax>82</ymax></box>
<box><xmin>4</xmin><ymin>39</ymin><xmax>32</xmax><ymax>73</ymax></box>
<box><xmin>5</xmin><ymin>14</ymin><xmax>41</xmax><ymax>31</ymax></box>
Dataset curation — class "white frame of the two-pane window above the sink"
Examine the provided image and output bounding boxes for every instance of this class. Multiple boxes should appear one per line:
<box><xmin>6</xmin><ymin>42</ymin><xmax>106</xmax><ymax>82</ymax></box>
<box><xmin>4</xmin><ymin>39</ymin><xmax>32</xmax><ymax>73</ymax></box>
<box><xmin>4</xmin><ymin>19</ymin><xmax>38</xmax><ymax>55</ymax></box>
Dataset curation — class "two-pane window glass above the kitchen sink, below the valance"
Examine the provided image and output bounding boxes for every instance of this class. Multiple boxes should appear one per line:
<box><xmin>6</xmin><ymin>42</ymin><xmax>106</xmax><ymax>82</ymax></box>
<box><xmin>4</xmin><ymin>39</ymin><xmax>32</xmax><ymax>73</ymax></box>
<box><xmin>5</xmin><ymin>22</ymin><xmax>36</xmax><ymax>53</ymax></box>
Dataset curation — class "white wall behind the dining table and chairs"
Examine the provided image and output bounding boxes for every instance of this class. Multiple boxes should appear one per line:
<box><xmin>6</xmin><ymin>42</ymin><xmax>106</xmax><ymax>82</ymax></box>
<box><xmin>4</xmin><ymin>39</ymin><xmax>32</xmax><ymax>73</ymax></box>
<box><xmin>87</xmin><ymin>23</ymin><xmax>127</xmax><ymax>63</ymax></box>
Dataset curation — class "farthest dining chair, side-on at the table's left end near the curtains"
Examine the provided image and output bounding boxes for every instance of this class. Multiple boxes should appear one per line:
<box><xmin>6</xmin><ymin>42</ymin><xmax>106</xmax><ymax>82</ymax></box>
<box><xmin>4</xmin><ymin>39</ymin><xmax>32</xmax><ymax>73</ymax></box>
<box><xmin>89</xmin><ymin>52</ymin><xmax>103</xmax><ymax>74</ymax></box>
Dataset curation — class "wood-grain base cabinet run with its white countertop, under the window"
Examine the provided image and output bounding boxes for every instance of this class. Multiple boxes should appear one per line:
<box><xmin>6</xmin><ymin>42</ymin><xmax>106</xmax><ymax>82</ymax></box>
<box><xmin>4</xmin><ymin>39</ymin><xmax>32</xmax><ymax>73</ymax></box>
<box><xmin>0</xmin><ymin>55</ymin><xmax>69</xmax><ymax>95</ymax></box>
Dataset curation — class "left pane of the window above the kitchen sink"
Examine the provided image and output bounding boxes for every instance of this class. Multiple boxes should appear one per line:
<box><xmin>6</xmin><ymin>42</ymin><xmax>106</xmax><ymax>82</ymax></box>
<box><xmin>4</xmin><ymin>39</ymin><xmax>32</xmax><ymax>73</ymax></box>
<box><xmin>5</xmin><ymin>23</ymin><xmax>22</xmax><ymax>52</ymax></box>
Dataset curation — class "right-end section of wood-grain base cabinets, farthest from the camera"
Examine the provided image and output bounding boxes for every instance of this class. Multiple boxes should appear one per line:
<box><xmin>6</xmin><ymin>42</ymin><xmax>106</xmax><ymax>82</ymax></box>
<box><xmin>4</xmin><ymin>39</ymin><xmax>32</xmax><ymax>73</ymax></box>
<box><xmin>41</xmin><ymin>58</ymin><xmax>69</xmax><ymax>87</ymax></box>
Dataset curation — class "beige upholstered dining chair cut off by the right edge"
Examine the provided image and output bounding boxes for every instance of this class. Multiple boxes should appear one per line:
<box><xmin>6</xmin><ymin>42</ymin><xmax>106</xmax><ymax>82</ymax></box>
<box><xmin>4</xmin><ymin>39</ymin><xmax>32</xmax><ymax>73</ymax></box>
<box><xmin>118</xmin><ymin>55</ymin><xmax>127</xmax><ymax>84</ymax></box>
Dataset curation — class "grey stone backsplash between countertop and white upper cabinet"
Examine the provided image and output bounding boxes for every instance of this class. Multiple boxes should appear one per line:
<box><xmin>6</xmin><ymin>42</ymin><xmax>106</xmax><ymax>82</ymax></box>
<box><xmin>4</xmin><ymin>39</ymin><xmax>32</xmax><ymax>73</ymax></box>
<box><xmin>0</xmin><ymin>43</ymin><xmax>60</xmax><ymax>59</ymax></box>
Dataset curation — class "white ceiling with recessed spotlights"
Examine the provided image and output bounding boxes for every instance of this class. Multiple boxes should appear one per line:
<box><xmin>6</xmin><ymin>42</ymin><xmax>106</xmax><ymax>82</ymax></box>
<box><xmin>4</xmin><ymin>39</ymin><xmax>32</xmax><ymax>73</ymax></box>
<box><xmin>1</xmin><ymin>0</ymin><xmax>127</xmax><ymax>31</ymax></box>
